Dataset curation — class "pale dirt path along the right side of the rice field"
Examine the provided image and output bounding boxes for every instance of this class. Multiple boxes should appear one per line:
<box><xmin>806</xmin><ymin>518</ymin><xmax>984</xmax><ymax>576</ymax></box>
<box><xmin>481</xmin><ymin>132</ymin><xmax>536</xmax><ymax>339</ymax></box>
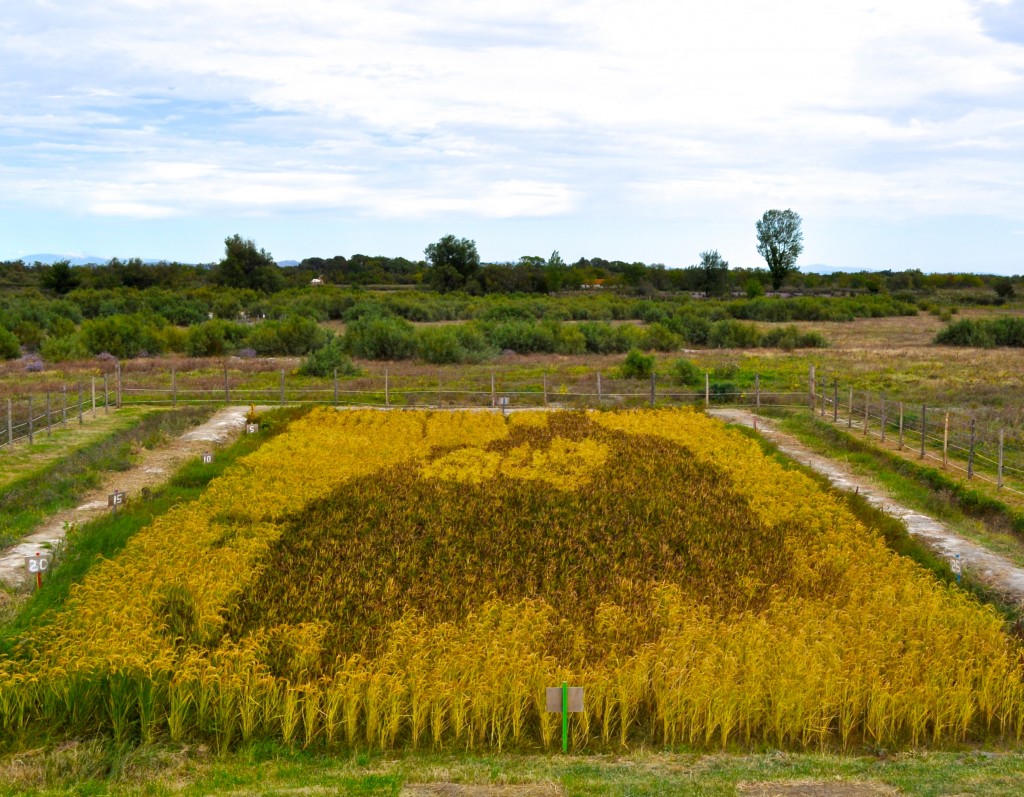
<box><xmin>709</xmin><ymin>408</ymin><xmax>1024</xmax><ymax>605</ymax></box>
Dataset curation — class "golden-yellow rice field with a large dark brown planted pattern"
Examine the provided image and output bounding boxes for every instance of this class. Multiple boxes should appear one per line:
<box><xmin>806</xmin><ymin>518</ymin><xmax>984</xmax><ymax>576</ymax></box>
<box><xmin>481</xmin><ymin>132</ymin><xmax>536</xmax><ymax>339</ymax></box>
<box><xmin>0</xmin><ymin>409</ymin><xmax>1024</xmax><ymax>752</ymax></box>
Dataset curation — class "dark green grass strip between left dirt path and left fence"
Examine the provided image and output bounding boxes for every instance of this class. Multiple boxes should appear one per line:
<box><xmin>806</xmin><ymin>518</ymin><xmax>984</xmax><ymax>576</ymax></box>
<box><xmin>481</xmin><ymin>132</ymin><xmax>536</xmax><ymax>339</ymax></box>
<box><xmin>0</xmin><ymin>408</ymin><xmax>211</xmax><ymax>548</ymax></box>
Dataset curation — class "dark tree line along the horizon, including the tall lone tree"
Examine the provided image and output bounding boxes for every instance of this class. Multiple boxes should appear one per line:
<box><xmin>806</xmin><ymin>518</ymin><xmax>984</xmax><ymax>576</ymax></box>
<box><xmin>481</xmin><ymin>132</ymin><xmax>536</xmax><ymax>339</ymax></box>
<box><xmin>0</xmin><ymin>209</ymin><xmax>1018</xmax><ymax>298</ymax></box>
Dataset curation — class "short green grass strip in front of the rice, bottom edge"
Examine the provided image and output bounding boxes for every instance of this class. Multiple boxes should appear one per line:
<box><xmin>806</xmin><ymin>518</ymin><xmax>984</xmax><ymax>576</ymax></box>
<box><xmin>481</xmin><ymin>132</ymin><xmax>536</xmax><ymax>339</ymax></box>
<box><xmin>0</xmin><ymin>742</ymin><xmax>1024</xmax><ymax>797</ymax></box>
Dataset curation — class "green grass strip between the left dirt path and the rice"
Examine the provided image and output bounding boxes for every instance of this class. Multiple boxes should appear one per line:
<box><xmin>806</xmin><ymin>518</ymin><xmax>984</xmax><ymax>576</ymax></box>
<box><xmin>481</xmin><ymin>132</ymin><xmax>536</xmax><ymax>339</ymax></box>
<box><xmin>0</xmin><ymin>408</ymin><xmax>308</xmax><ymax>656</ymax></box>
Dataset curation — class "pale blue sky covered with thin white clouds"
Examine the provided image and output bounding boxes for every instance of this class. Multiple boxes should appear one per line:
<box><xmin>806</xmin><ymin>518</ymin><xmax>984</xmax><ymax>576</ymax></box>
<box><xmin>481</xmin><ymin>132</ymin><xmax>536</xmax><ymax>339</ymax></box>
<box><xmin>0</xmin><ymin>0</ymin><xmax>1024</xmax><ymax>274</ymax></box>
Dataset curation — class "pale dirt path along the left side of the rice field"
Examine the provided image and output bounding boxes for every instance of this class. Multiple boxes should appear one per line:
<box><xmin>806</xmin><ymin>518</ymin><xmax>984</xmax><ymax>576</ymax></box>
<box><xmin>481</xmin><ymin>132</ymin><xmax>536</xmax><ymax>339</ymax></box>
<box><xmin>0</xmin><ymin>407</ymin><xmax>248</xmax><ymax>587</ymax></box>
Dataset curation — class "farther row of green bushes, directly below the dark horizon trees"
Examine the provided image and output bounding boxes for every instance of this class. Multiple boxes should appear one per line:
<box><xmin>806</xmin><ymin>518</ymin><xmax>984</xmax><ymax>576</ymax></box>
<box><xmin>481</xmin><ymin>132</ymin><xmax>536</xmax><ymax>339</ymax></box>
<box><xmin>0</xmin><ymin>286</ymin><xmax>916</xmax><ymax>353</ymax></box>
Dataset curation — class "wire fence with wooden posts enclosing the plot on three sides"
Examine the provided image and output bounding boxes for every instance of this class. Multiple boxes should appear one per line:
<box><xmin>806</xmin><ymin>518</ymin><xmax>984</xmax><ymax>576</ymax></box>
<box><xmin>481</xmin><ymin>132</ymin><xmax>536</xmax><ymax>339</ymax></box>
<box><xmin>6</xmin><ymin>366</ymin><xmax>1024</xmax><ymax>495</ymax></box>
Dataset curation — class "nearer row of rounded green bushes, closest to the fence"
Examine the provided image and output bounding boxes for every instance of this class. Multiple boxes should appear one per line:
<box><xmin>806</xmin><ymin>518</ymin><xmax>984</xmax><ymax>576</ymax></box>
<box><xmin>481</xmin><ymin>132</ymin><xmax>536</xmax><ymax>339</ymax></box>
<box><xmin>19</xmin><ymin>313</ymin><xmax>826</xmax><ymax>362</ymax></box>
